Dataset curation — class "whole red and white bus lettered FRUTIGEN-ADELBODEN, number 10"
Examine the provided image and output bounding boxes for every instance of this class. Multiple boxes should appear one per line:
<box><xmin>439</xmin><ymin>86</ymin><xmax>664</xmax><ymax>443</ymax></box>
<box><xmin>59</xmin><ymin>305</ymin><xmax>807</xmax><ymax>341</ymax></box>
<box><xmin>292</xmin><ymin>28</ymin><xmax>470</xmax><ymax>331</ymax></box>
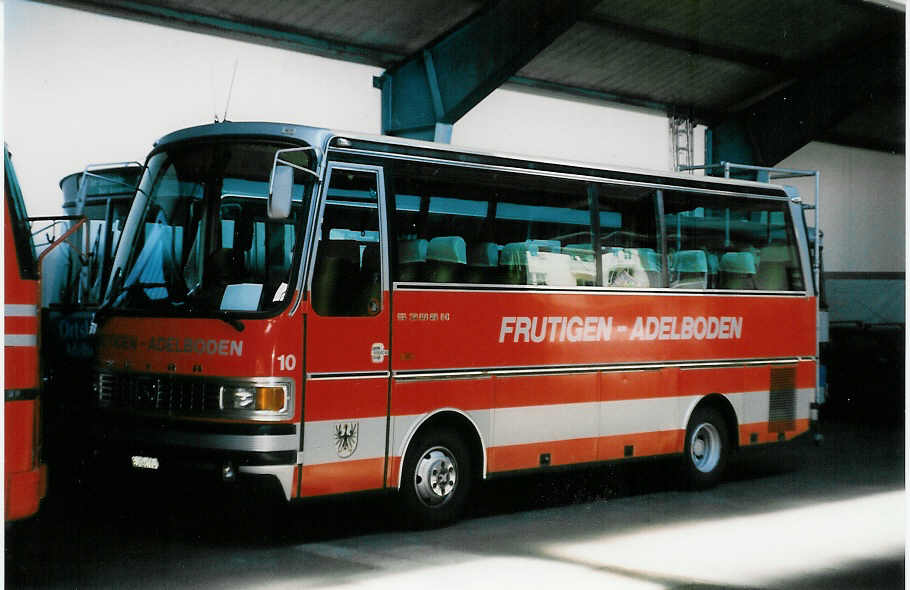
<box><xmin>95</xmin><ymin>123</ymin><xmax>816</xmax><ymax>524</ymax></box>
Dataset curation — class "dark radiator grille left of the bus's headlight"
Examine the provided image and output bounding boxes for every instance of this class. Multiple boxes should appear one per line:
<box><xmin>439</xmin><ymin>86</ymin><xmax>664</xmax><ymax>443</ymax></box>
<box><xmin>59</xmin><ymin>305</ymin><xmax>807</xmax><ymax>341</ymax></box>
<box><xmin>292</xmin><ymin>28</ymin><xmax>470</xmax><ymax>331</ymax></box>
<box><xmin>96</xmin><ymin>372</ymin><xmax>221</xmax><ymax>414</ymax></box>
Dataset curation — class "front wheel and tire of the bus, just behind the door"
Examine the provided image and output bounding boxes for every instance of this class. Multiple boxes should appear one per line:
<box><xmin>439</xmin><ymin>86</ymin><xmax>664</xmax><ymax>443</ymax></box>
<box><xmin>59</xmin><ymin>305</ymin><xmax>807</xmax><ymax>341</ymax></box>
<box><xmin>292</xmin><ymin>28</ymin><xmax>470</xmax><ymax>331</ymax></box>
<box><xmin>399</xmin><ymin>429</ymin><xmax>474</xmax><ymax>528</ymax></box>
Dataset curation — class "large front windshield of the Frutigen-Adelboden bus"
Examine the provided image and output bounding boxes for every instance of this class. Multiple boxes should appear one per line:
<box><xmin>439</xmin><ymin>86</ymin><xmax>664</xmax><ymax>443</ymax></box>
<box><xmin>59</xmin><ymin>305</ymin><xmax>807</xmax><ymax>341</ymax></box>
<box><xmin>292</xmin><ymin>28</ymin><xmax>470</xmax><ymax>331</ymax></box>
<box><xmin>108</xmin><ymin>140</ymin><xmax>315</xmax><ymax>314</ymax></box>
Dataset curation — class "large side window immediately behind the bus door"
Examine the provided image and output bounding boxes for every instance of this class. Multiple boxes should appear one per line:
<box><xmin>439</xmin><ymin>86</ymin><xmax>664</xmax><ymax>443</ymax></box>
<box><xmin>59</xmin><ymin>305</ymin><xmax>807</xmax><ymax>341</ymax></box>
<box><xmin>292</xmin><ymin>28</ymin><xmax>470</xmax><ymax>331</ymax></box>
<box><xmin>392</xmin><ymin>162</ymin><xmax>595</xmax><ymax>286</ymax></box>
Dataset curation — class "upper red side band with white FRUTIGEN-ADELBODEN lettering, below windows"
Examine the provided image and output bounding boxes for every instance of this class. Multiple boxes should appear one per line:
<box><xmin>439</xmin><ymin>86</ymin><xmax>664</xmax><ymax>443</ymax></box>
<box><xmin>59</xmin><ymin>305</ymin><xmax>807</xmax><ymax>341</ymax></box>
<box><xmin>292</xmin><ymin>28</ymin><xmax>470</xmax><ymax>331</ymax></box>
<box><xmin>392</xmin><ymin>288</ymin><xmax>815</xmax><ymax>371</ymax></box>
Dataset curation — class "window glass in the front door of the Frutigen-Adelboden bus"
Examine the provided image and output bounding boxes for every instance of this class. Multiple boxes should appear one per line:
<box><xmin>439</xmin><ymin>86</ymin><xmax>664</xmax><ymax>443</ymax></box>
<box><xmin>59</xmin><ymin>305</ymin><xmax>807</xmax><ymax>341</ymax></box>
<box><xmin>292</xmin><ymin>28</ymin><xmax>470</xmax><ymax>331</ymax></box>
<box><xmin>312</xmin><ymin>169</ymin><xmax>382</xmax><ymax>316</ymax></box>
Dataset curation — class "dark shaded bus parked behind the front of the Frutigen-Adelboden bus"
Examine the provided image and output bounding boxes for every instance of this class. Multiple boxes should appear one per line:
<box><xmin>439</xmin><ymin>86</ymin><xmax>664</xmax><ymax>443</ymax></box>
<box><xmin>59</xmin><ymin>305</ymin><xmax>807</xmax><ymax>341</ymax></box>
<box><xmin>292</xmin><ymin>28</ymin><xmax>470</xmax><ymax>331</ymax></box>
<box><xmin>33</xmin><ymin>162</ymin><xmax>142</xmax><ymax>486</ymax></box>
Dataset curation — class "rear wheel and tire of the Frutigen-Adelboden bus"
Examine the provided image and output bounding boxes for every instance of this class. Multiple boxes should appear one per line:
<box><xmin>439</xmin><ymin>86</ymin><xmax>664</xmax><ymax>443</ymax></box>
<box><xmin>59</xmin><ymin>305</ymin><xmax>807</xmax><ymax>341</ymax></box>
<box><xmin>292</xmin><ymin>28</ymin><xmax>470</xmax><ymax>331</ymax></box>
<box><xmin>683</xmin><ymin>406</ymin><xmax>730</xmax><ymax>490</ymax></box>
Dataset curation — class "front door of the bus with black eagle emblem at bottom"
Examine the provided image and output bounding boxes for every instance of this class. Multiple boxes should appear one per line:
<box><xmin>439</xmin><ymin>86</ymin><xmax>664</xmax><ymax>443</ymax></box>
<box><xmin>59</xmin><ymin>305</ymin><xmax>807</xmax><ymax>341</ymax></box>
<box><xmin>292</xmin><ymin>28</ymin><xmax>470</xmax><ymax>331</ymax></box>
<box><xmin>300</xmin><ymin>163</ymin><xmax>390</xmax><ymax>496</ymax></box>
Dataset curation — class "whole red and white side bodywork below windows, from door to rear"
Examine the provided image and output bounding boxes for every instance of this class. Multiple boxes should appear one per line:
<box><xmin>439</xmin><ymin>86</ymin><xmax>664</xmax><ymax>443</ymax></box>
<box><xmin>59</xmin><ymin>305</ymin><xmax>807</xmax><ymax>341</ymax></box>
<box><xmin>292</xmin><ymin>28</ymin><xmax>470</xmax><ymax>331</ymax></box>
<box><xmin>390</xmin><ymin>289</ymin><xmax>815</xmax><ymax>472</ymax></box>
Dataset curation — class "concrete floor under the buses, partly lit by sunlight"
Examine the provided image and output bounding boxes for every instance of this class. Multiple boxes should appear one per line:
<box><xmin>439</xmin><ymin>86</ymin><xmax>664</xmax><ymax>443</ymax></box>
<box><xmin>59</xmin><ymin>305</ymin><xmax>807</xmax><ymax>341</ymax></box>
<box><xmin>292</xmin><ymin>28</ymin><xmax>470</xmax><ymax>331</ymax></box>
<box><xmin>5</xmin><ymin>424</ymin><xmax>906</xmax><ymax>590</ymax></box>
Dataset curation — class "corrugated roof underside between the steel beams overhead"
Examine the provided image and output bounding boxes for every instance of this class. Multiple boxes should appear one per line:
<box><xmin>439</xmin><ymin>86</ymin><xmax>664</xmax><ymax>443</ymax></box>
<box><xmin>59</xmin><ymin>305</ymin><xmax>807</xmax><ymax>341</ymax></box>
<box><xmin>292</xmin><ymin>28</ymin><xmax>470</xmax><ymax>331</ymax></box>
<box><xmin>41</xmin><ymin>0</ymin><xmax>906</xmax><ymax>151</ymax></box>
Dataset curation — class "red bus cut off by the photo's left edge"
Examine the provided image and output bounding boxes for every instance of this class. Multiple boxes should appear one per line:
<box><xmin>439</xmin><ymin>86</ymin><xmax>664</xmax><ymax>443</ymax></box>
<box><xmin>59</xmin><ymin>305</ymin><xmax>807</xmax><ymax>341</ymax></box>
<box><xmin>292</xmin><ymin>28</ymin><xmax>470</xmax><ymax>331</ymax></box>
<box><xmin>3</xmin><ymin>145</ymin><xmax>47</xmax><ymax>521</ymax></box>
